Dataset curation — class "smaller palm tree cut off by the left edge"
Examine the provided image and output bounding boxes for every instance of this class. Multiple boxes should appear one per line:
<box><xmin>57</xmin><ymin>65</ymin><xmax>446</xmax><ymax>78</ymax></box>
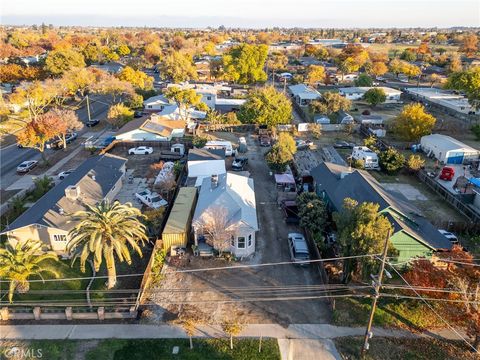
<box><xmin>0</xmin><ymin>241</ymin><xmax>59</xmax><ymax>303</ymax></box>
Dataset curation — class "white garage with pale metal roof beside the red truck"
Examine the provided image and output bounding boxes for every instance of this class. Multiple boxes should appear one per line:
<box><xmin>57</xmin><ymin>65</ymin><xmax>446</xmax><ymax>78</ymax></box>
<box><xmin>420</xmin><ymin>134</ymin><xmax>480</xmax><ymax>164</ymax></box>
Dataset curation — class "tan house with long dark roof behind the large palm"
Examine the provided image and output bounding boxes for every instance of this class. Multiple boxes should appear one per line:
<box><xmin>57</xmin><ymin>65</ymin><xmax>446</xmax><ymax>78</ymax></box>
<box><xmin>2</xmin><ymin>154</ymin><xmax>127</xmax><ymax>257</ymax></box>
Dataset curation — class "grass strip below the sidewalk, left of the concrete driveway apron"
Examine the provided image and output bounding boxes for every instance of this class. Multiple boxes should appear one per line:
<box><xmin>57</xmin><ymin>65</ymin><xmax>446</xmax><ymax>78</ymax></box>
<box><xmin>86</xmin><ymin>339</ymin><xmax>280</xmax><ymax>360</ymax></box>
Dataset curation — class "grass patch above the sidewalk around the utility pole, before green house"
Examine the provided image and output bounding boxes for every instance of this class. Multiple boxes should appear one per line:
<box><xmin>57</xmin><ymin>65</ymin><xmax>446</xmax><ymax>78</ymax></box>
<box><xmin>333</xmin><ymin>298</ymin><xmax>444</xmax><ymax>330</ymax></box>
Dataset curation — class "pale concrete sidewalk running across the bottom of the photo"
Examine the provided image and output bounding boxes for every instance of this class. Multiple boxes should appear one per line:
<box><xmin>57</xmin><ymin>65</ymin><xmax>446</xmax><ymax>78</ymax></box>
<box><xmin>0</xmin><ymin>324</ymin><xmax>464</xmax><ymax>340</ymax></box>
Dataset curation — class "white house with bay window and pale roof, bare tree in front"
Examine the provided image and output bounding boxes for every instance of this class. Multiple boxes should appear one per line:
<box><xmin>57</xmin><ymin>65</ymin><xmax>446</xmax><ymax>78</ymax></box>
<box><xmin>192</xmin><ymin>173</ymin><xmax>259</xmax><ymax>257</ymax></box>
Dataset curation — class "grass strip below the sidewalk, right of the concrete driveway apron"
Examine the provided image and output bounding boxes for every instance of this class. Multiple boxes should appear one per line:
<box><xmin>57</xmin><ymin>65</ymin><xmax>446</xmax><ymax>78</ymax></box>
<box><xmin>334</xmin><ymin>337</ymin><xmax>475</xmax><ymax>360</ymax></box>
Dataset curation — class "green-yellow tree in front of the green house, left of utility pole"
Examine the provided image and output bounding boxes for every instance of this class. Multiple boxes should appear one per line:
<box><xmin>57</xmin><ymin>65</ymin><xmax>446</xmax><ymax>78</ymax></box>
<box><xmin>333</xmin><ymin>198</ymin><xmax>394</xmax><ymax>283</ymax></box>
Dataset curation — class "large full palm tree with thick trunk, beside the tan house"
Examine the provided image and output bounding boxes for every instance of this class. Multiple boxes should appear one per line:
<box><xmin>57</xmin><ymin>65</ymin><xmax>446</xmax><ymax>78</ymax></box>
<box><xmin>67</xmin><ymin>201</ymin><xmax>148</xmax><ymax>289</ymax></box>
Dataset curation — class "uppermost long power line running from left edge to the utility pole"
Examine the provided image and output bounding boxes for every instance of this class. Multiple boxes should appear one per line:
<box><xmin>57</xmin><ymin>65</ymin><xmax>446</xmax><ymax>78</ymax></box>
<box><xmin>0</xmin><ymin>254</ymin><xmax>380</xmax><ymax>283</ymax></box>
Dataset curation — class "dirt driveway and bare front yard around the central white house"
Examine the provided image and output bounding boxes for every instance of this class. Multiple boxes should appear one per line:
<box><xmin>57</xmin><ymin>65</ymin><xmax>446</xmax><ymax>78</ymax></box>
<box><xmin>151</xmin><ymin>134</ymin><xmax>331</xmax><ymax>325</ymax></box>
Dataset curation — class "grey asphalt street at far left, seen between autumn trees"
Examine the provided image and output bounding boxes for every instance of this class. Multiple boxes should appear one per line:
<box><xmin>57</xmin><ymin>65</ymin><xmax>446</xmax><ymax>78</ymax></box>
<box><xmin>0</xmin><ymin>96</ymin><xmax>110</xmax><ymax>189</ymax></box>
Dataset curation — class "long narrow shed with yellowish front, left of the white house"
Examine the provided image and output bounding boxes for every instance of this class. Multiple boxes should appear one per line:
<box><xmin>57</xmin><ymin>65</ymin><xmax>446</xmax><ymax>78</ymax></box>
<box><xmin>162</xmin><ymin>187</ymin><xmax>197</xmax><ymax>251</ymax></box>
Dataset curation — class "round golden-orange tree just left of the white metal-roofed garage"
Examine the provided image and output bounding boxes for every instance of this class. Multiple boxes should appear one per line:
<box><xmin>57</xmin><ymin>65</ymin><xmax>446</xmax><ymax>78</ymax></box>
<box><xmin>393</xmin><ymin>103</ymin><xmax>437</xmax><ymax>141</ymax></box>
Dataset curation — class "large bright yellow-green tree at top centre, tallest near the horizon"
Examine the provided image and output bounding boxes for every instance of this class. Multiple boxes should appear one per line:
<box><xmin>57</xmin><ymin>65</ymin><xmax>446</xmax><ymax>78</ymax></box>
<box><xmin>223</xmin><ymin>44</ymin><xmax>268</xmax><ymax>84</ymax></box>
